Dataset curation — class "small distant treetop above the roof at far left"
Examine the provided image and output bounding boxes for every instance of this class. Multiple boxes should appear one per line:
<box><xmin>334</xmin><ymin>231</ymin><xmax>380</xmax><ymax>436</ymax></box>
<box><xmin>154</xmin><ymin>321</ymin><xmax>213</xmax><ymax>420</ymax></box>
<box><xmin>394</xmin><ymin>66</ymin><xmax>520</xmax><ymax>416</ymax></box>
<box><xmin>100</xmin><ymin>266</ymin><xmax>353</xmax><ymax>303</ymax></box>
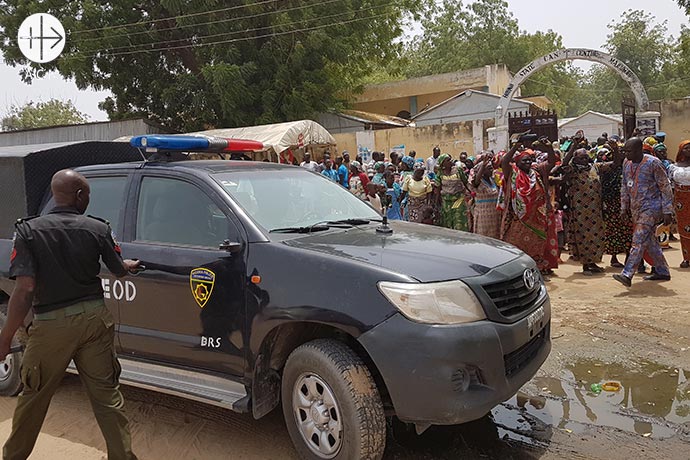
<box><xmin>0</xmin><ymin>99</ymin><xmax>89</xmax><ymax>131</ymax></box>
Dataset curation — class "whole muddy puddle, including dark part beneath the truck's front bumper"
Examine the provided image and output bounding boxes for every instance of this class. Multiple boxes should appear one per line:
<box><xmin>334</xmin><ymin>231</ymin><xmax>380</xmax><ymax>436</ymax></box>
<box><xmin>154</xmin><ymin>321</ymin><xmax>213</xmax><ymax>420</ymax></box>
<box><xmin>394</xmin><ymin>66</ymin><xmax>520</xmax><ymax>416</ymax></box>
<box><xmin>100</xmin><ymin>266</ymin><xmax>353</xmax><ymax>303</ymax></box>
<box><xmin>388</xmin><ymin>360</ymin><xmax>690</xmax><ymax>459</ymax></box>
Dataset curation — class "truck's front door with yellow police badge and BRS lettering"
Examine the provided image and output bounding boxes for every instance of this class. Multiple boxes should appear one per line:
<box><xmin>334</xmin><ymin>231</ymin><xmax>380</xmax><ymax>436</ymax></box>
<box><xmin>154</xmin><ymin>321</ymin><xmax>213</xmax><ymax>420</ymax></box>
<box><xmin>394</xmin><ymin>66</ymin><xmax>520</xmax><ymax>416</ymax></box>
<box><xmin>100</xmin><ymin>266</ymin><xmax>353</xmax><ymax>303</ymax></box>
<box><xmin>120</xmin><ymin>169</ymin><xmax>246</xmax><ymax>375</ymax></box>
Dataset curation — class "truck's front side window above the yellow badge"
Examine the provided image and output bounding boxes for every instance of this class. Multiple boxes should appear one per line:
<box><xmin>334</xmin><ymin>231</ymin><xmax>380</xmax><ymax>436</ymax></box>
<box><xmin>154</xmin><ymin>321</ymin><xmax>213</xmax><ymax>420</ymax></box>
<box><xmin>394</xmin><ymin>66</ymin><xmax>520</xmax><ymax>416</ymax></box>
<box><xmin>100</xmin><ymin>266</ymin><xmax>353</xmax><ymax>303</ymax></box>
<box><xmin>136</xmin><ymin>177</ymin><xmax>232</xmax><ymax>248</ymax></box>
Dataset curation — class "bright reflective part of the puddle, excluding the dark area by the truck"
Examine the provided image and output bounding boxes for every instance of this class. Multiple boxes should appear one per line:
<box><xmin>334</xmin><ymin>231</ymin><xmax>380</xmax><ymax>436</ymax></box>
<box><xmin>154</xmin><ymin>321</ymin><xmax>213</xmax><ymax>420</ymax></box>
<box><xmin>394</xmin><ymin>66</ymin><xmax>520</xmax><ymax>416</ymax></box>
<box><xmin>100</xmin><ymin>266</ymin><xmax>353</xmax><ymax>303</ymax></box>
<box><xmin>494</xmin><ymin>360</ymin><xmax>690</xmax><ymax>439</ymax></box>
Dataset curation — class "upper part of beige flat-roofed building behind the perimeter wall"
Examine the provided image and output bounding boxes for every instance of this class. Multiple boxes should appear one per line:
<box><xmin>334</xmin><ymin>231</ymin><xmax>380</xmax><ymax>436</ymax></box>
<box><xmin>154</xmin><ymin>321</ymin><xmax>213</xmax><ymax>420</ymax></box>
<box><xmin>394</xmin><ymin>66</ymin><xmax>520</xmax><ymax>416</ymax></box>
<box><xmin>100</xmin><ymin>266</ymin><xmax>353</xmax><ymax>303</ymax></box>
<box><xmin>352</xmin><ymin>64</ymin><xmax>520</xmax><ymax>119</ymax></box>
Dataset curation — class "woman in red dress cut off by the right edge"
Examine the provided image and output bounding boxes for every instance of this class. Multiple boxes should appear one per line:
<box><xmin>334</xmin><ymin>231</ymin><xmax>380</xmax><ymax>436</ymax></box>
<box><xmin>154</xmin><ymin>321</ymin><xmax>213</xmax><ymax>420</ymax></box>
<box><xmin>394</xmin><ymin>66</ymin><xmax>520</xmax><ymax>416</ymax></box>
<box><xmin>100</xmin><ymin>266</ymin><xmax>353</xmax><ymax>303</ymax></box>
<box><xmin>669</xmin><ymin>140</ymin><xmax>690</xmax><ymax>268</ymax></box>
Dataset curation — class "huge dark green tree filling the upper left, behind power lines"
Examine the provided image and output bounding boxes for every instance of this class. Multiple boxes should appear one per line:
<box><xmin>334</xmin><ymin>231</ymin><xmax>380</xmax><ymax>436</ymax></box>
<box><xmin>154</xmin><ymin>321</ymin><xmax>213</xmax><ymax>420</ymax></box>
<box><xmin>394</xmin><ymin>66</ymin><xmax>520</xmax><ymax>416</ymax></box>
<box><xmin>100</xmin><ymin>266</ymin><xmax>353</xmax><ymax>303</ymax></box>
<box><xmin>0</xmin><ymin>0</ymin><xmax>424</xmax><ymax>130</ymax></box>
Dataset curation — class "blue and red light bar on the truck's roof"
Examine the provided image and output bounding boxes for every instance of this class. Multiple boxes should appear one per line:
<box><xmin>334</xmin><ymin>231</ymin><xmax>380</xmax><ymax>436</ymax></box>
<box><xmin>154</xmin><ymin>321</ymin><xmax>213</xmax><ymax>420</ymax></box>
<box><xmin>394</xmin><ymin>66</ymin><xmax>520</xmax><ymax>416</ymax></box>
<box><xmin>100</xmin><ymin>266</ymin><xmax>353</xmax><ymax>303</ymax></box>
<box><xmin>129</xmin><ymin>134</ymin><xmax>264</xmax><ymax>152</ymax></box>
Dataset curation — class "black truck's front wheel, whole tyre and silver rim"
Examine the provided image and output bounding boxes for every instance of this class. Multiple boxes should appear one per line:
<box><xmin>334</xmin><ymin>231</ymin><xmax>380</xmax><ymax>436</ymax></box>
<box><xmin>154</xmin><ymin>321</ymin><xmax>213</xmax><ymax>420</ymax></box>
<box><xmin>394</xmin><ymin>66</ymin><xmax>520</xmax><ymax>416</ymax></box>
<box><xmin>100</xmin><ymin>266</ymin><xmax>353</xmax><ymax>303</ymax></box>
<box><xmin>281</xmin><ymin>339</ymin><xmax>386</xmax><ymax>460</ymax></box>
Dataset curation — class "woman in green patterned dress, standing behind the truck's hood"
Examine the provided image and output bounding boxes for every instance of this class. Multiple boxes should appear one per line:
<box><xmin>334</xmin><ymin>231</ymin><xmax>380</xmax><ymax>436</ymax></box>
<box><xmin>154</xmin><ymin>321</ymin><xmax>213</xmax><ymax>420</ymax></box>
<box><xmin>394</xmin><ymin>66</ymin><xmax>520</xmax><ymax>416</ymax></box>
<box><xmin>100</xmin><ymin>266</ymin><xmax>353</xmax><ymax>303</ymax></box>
<box><xmin>436</xmin><ymin>153</ymin><xmax>470</xmax><ymax>232</ymax></box>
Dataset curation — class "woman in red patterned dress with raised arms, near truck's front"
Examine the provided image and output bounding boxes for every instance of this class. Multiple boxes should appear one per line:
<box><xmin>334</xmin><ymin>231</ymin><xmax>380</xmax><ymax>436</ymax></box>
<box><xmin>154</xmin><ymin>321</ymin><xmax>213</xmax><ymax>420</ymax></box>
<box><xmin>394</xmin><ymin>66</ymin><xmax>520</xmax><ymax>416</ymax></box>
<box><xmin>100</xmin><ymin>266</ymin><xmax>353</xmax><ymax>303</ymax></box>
<box><xmin>501</xmin><ymin>142</ymin><xmax>558</xmax><ymax>275</ymax></box>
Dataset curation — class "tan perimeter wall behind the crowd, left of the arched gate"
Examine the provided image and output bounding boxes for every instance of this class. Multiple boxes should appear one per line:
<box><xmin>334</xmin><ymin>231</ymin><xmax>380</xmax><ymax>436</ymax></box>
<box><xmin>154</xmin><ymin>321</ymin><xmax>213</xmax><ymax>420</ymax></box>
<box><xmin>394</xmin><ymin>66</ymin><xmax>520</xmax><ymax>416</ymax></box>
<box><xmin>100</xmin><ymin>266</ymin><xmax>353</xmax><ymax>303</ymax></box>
<box><xmin>333</xmin><ymin>120</ymin><xmax>486</xmax><ymax>158</ymax></box>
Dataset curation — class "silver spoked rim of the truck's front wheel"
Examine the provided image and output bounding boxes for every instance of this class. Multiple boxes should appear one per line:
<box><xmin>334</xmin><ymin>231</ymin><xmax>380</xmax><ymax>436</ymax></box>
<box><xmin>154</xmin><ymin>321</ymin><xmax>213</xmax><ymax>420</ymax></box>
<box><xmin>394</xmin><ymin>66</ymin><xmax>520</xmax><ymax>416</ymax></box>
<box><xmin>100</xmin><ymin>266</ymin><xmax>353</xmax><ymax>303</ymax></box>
<box><xmin>292</xmin><ymin>373</ymin><xmax>343</xmax><ymax>458</ymax></box>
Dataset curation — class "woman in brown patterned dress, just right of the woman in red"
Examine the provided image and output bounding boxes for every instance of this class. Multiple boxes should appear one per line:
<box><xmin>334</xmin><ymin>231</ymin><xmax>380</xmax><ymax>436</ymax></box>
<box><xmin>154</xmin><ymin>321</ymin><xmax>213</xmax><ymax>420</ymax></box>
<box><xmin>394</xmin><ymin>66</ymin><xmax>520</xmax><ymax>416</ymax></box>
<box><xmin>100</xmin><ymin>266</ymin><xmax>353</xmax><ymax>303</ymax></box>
<box><xmin>561</xmin><ymin>149</ymin><xmax>605</xmax><ymax>276</ymax></box>
